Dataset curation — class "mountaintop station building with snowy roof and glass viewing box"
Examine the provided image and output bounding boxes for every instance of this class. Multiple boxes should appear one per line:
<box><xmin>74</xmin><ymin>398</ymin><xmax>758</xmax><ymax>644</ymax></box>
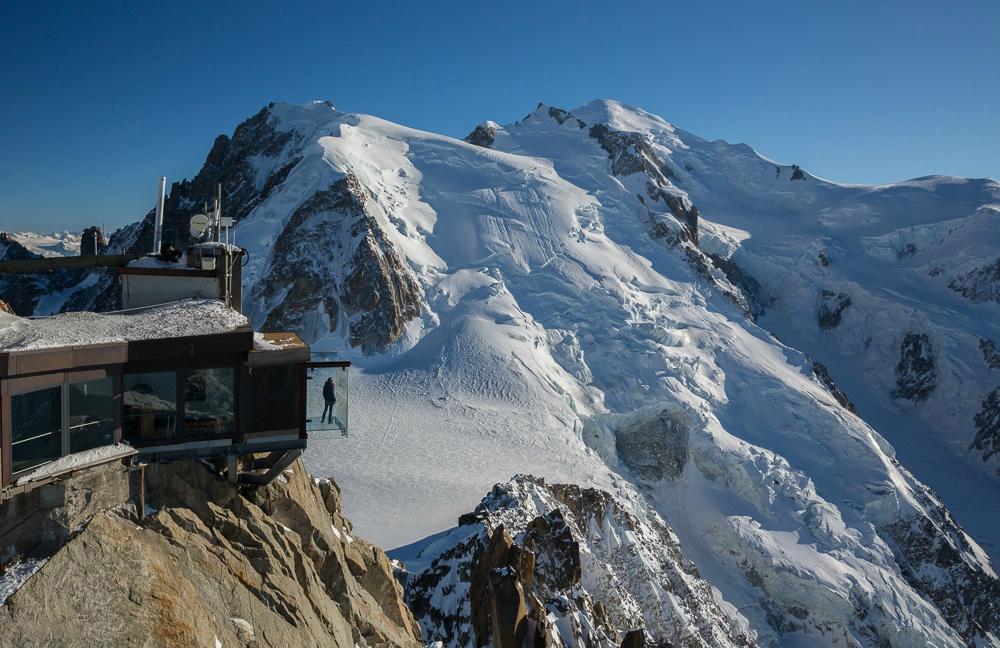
<box><xmin>0</xmin><ymin>249</ymin><xmax>349</xmax><ymax>506</ymax></box>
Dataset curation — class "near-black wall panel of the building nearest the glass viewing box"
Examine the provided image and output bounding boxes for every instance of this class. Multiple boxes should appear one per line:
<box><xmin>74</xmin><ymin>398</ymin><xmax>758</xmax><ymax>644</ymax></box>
<box><xmin>240</xmin><ymin>365</ymin><xmax>304</xmax><ymax>434</ymax></box>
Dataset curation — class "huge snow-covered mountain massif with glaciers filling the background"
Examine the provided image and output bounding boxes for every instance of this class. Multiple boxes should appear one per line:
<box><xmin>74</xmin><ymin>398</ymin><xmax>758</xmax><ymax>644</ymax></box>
<box><xmin>76</xmin><ymin>101</ymin><xmax>1000</xmax><ymax>646</ymax></box>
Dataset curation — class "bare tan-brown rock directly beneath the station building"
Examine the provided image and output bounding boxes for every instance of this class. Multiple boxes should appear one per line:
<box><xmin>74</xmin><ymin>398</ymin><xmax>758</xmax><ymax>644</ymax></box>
<box><xmin>0</xmin><ymin>462</ymin><xmax>421</xmax><ymax>648</ymax></box>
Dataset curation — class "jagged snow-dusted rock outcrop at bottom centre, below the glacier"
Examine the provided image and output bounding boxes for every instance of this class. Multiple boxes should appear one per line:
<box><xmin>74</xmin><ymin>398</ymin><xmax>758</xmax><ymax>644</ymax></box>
<box><xmin>405</xmin><ymin>475</ymin><xmax>754</xmax><ymax>648</ymax></box>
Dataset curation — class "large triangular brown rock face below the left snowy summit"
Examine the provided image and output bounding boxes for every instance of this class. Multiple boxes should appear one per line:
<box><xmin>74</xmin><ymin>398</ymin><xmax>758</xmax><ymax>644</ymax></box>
<box><xmin>254</xmin><ymin>176</ymin><xmax>421</xmax><ymax>353</ymax></box>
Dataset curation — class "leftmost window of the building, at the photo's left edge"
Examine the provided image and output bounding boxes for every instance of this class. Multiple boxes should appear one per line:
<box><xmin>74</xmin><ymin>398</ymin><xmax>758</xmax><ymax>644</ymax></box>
<box><xmin>10</xmin><ymin>386</ymin><xmax>62</xmax><ymax>473</ymax></box>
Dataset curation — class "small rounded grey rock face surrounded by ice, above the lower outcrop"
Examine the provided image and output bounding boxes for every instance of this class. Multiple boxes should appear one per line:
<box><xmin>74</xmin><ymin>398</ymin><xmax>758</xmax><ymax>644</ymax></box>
<box><xmin>615</xmin><ymin>410</ymin><xmax>691</xmax><ymax>480</ymax></box>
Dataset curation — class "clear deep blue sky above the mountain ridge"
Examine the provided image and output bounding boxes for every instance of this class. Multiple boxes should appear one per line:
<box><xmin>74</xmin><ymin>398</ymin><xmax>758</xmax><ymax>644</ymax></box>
<box><xmin>0</xmin><ymin>0</ymin><xmax>1000</xmax><ymax>231</ymax></box>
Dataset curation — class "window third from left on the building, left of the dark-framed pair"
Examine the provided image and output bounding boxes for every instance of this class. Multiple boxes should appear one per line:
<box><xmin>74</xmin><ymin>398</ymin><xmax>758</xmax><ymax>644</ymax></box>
<box><xmin>122</xmin><ymin>371</ymin><xmax>177</xmax><ymax>442</ymax></box>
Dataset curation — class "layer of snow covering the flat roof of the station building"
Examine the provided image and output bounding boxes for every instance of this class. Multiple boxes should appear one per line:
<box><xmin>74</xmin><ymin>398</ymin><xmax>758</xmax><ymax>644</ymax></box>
<box><xmin>0</xmin><ymin>299</ymin><xmax>248</xmax><ymax>351</ymax></box>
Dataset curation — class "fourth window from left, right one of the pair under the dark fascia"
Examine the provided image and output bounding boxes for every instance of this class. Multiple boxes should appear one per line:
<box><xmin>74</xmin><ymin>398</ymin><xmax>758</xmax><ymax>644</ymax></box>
<box><xmin>184</xmin><ymin>367</ymin><xmax>236</xmax><ymax>435</ymax></box>
